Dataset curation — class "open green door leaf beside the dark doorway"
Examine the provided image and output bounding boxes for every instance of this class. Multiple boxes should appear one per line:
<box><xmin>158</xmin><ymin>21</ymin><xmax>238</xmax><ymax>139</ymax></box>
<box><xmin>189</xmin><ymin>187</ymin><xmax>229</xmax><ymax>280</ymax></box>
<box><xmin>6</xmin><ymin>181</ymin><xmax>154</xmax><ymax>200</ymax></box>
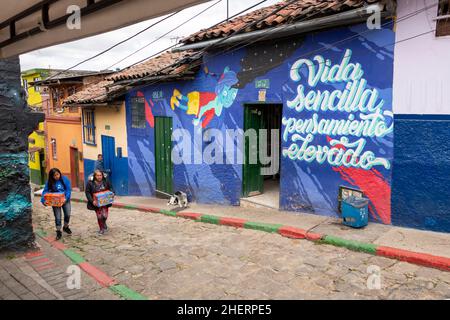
<box><xmin>242</xmin><ymin>105</ymin><xmax>265</xmax><ymax>197</ymax></box>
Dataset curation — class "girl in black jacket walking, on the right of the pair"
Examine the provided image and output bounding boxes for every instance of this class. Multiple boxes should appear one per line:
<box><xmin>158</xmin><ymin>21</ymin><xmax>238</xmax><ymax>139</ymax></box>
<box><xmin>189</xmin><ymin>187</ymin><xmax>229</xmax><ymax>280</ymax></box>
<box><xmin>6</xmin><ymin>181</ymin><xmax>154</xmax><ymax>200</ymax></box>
<box><xmin>85</xmin><ymin>170</ymin><xmax>114</xmax><ymax>235</ymax></box>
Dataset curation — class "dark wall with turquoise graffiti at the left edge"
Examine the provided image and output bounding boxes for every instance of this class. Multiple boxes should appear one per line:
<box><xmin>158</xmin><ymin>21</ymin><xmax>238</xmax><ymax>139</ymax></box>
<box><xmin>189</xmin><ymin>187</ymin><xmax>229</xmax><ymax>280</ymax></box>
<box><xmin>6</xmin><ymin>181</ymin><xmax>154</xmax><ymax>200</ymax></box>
<box><xmin>0</xmin><ymin>57</ymin><xmax>44</xmax><ymax>250</ymax></box>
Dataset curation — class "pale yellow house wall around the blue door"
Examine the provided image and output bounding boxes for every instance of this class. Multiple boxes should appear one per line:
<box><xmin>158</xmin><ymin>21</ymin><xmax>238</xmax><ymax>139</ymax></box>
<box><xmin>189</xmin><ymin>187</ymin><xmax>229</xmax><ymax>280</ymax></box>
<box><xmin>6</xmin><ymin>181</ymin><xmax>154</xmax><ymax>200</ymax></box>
<box><xmin>83</xmin><ymin>102</ymin><xmax>128</xmax><ymax>160</ymax></box>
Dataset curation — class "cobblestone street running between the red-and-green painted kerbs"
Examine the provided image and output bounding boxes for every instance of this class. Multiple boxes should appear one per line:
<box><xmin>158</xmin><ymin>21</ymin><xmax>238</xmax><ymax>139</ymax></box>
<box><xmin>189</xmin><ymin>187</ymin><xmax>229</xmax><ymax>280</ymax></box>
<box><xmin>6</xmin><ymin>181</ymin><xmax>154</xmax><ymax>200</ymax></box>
<box><xmin>33</xmin><ymin>199</ymin><xmax>450</xmax><ymax>299</ymax></box>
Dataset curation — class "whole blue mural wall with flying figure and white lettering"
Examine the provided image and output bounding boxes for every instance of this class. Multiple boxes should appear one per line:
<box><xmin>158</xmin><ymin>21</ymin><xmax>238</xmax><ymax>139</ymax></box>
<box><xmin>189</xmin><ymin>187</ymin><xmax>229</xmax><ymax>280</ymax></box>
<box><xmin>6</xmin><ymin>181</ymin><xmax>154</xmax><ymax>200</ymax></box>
<box><xmin>127</xmin><ymin>24</ymin><xmax>395</xmax><ymax>224</ymax></box>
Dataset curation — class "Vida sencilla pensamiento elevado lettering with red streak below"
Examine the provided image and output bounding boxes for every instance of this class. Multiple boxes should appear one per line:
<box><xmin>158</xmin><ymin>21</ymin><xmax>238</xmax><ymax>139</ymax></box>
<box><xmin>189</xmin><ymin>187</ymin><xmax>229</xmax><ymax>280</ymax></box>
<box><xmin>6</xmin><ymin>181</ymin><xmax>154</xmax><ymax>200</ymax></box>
<box><xmin>282</xmin><ymin>49</ymin><xmax>393</xmax><ymax>223</ymax></box>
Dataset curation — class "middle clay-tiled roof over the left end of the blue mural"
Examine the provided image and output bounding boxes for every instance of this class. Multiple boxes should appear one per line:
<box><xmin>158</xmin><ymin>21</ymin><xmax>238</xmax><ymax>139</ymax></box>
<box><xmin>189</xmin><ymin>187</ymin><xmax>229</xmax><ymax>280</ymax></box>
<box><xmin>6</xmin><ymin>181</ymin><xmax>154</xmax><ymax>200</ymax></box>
<box><xmin>106</xmin><ymin>51</ymin><xmax>197</xmax><ymax>81</ymax></box>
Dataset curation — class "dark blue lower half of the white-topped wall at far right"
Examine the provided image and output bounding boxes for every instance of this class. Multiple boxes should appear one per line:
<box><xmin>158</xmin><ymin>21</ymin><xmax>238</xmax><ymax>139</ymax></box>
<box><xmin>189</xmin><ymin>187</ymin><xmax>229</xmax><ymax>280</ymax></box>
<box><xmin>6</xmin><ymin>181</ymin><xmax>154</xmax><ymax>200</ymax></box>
<box><xmin>392</xmin><ymin>115</ymin><xmax>450</xmax><ymax>232</ymax></box>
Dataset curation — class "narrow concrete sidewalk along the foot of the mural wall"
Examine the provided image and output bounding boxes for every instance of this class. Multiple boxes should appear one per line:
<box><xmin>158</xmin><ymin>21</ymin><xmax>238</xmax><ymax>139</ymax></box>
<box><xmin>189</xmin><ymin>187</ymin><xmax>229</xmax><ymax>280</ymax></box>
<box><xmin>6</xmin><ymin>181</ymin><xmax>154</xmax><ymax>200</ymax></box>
<box><xmin>68</xmin><ymin>192</ymin><xmax>450</xmax><ymax>258</ymax></box>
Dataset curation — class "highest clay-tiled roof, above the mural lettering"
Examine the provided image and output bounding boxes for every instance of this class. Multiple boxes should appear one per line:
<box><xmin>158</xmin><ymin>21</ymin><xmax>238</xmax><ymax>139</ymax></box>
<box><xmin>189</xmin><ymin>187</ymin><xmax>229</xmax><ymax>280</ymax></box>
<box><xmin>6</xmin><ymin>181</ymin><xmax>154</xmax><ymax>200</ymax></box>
<box><xmin>181</xmin><ymin>0</ymin><xmax>384</xmax><ymax>44</ymax></box>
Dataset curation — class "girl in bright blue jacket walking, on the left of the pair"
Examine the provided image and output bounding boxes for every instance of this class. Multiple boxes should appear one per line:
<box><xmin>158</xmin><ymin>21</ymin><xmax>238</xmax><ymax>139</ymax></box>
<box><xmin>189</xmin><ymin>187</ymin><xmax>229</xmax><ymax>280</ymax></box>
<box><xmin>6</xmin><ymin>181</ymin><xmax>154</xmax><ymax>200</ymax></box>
<box><xmin>41</xmin><ymin>168</ymin><xmax>72</xmax><ymax>240</ymax></box>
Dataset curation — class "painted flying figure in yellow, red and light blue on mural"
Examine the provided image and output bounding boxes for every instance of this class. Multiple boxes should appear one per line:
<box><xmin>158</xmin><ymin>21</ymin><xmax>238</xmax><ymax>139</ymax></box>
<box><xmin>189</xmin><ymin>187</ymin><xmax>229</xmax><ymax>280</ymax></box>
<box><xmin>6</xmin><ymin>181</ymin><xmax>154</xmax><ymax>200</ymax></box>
<box><xmin>170</xmin><ymin>67</ymin><xmax>238</xmax><ymax>128</ymax></box>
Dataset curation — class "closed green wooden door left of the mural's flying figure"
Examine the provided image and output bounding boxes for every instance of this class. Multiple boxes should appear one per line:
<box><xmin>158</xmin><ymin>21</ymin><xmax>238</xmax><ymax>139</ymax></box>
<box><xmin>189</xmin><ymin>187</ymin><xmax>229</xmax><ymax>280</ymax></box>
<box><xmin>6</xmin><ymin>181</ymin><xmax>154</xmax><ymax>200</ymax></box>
<box><xmin>155</xmin><ymin>117</ymin><xmax>173</xmax><ymax>194</ymax></box>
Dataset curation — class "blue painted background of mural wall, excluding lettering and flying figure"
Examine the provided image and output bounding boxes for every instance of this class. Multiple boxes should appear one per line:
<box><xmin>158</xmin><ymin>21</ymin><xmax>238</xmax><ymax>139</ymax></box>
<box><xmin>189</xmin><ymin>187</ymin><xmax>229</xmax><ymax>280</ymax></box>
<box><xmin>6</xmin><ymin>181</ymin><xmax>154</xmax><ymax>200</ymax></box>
<box><xmin>126</xmin><ymin>24</ymin><xmax>394</xmax><ymax>223</ymax></box>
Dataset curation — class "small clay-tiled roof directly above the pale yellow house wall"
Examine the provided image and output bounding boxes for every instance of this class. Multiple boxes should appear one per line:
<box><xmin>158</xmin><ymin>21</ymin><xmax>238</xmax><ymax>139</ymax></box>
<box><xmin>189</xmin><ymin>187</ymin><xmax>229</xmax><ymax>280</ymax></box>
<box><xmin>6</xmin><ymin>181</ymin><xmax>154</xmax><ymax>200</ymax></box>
<box><xmin>64</xmin><ymin>80</ymin><xmax>123</xmax><ymax>105</ymax></box>
